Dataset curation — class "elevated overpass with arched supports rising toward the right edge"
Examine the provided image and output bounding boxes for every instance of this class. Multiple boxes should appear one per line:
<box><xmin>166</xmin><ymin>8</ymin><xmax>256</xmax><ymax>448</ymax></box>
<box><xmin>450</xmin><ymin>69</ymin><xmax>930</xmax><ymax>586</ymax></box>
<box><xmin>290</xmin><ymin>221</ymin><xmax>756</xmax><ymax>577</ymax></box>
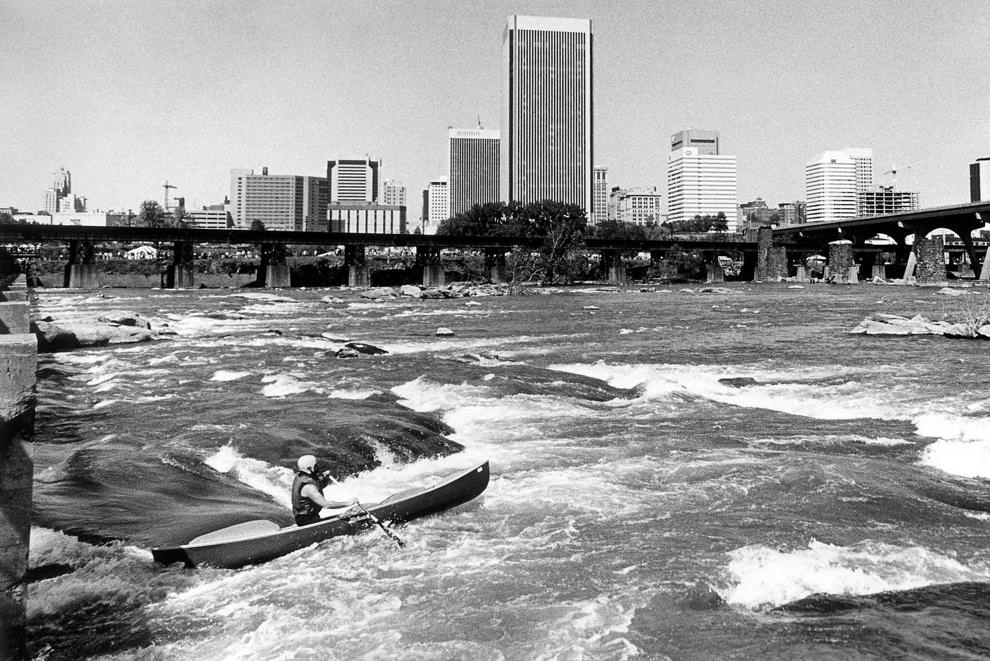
<box><xmin>771</xmin><ymin>201</ymin><xmax>990</xmax><ymax>282</ymax></box>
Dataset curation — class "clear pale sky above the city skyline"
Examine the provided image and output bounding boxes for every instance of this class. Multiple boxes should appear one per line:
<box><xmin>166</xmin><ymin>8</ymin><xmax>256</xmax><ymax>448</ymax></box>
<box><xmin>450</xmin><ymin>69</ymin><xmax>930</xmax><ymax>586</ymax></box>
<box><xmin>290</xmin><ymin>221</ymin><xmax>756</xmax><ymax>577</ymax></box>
<box><xmin>0</xmin><ymin>0</ymin><xmax>990</xmax><ymax>213</ymax></box>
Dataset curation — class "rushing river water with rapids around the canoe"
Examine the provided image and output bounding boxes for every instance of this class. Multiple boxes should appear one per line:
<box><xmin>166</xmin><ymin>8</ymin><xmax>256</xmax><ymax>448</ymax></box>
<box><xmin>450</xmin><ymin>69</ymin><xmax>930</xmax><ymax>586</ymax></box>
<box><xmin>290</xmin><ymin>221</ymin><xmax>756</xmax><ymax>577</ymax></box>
<box><xmin>28</xmin><ymin>284</ymin><xmax>990</xmax><ymax>660</ymax></box>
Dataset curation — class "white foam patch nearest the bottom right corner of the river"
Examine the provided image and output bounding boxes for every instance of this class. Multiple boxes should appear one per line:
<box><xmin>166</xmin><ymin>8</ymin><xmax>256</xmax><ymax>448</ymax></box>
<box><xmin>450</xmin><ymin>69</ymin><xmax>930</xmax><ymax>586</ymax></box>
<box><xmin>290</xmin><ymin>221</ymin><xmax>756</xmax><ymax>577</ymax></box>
<box><xmin>719</xmin><ymin>540</ymin><xmax>990</xmax><ymax>609</ymax></box>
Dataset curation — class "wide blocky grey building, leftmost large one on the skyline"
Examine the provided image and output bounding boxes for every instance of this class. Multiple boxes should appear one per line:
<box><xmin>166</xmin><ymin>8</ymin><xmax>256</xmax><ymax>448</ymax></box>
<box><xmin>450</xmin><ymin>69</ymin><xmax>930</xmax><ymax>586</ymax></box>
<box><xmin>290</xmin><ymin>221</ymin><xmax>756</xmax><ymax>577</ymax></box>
<box><xmin>230</xmin><ymin>168</ymin><xmax>330</xmax><ymax>232</ymax></box>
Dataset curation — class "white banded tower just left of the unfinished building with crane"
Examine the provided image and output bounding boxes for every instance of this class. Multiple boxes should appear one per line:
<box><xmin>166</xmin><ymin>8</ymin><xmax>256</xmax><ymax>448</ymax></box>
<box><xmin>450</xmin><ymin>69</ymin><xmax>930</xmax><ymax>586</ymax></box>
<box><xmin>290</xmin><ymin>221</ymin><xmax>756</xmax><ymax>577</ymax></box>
<box><xmin>804</xmin><ymin>151</ymin><xmax>859</xmax><ymax>223</ymax></box>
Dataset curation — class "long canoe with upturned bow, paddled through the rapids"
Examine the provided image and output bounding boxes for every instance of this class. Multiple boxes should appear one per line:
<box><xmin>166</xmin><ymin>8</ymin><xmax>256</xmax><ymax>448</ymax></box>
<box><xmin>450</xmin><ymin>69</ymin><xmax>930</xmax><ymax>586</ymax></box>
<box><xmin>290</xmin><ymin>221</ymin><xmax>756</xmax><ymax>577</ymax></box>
<box><xmin>151</xmin><ymin>461</ymin><xmax>489</xmax><ymax>569</ymax></box>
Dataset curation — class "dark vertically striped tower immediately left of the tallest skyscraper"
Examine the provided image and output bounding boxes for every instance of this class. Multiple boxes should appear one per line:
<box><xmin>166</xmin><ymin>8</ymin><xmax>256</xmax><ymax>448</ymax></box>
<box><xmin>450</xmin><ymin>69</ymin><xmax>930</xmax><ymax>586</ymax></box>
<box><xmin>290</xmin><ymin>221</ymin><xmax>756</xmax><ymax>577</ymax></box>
<box><xmin>447</xmin><ymin>129</ymin><xmax>502</xmax><ymax>216</ymax></box>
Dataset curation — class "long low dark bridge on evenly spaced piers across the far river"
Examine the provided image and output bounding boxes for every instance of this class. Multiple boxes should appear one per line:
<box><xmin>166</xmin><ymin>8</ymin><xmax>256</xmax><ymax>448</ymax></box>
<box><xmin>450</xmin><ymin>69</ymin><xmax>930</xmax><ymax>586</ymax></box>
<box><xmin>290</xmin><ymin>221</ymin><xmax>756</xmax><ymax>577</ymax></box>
<box><xmin>0</xmin><ymin>223</ymin><xmax>759</xmax><ymax>288</ymax></box>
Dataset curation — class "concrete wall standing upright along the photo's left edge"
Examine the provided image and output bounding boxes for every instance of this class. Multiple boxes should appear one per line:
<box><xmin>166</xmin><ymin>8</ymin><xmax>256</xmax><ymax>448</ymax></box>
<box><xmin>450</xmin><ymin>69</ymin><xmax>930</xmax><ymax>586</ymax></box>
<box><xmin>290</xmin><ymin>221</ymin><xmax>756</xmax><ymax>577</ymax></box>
<box><xmin>0</xmin><ymin>276</ymin><xmax>38</xmax><ymax>659</ymax></box>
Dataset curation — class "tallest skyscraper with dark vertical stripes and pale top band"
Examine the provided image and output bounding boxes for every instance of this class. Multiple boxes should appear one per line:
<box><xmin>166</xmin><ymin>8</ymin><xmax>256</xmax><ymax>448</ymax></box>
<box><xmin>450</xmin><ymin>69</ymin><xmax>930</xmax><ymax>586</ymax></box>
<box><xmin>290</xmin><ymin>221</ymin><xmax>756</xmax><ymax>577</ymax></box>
<box><xmin>501</xmin><ymin>15</ymin><xmax>592</xmax><ymax>213</ymax></box>
